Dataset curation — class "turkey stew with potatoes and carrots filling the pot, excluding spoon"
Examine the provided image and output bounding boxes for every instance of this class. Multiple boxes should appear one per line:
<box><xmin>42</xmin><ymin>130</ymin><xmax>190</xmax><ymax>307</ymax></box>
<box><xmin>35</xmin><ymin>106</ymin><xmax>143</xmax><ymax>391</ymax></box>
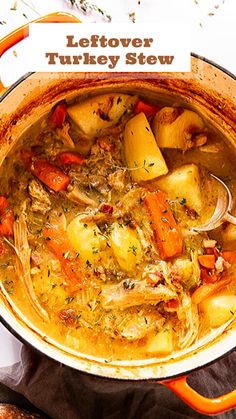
<box><xmin>0</xmin><ymin>93</ymin><xmax>236</xmax><ymax>362</ymax></box>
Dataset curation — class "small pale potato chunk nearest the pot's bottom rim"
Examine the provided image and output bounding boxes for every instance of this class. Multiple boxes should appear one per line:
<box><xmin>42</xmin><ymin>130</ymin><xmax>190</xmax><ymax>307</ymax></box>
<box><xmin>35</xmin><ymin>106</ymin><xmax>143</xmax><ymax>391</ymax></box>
<box><xmin>146</xmin><ymin>324</ymin><xmax>173</xmax><ymax>356</ymax></box>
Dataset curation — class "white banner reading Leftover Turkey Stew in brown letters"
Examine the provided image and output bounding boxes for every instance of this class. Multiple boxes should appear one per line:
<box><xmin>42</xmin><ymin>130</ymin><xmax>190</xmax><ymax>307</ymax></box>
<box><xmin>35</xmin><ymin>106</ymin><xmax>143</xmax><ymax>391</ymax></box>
<box><xmin>28</xmin><ymin>22</ymin><xmax>191</xmax><ymax>72</ymax></box>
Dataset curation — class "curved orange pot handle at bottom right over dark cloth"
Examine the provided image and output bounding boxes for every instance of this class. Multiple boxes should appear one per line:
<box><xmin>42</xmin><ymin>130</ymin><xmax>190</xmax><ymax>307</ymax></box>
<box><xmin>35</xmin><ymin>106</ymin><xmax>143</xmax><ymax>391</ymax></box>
<box><xmin>158</xmin><ymin>375</ymin><xmax>236</xmax><ymax>416</ymax></box>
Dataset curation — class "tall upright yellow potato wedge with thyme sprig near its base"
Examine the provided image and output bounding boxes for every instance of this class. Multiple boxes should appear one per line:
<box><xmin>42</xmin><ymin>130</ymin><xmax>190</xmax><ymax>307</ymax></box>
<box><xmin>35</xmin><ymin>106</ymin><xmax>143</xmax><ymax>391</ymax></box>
<box><xmin>124</xmin><ymin>112</ymin><xmax>168</xmax><ymax>181</ymax></box>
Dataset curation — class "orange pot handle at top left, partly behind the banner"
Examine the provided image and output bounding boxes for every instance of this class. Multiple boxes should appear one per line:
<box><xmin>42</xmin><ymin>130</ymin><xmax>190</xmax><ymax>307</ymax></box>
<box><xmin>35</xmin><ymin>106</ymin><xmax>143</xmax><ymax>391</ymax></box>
<box><xmin>0</xmin><ymin>12</ymin><xmax>80</xmax><ymax>95</ymax></box>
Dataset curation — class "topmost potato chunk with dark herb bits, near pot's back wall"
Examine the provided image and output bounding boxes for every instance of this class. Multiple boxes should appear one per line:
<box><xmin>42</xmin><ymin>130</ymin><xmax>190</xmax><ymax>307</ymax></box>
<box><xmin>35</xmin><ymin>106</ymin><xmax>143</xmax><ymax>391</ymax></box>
<box><xmin>67</xmin><ymin>93</ymin><xmax>137</xmax><ymax>139</ymax></box>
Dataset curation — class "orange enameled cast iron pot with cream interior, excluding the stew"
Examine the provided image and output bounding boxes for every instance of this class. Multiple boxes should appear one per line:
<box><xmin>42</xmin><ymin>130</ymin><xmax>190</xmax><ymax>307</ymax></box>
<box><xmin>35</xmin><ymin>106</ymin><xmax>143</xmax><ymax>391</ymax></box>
<box><xmin>0</xmin><ymin>13</ymin><xmax>236</xmax><ymax>415</ymax></box>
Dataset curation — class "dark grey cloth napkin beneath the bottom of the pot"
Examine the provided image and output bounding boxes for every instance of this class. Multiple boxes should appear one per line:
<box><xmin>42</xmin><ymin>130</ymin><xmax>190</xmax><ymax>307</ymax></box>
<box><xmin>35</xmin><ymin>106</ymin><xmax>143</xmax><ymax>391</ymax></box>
<box><xmin>0</xmin><ymin>346</ymin><xmax>236</xmax><ymax>419</ymax></box>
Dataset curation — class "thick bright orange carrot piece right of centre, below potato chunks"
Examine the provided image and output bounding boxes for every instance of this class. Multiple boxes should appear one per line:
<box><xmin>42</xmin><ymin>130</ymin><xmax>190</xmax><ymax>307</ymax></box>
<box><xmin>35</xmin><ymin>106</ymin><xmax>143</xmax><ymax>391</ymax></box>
<box><xmin>144</xmin><ymin>190</ymin><xmax>183</xmax><ymax>260</ymax></box>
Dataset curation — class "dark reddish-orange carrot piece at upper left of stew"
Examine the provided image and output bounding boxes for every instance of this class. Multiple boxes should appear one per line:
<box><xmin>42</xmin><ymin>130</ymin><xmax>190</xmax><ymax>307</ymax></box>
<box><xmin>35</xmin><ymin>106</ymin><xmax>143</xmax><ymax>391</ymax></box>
<box><xmin>21</xmin><ymin>149</ymin><xmax>70</xmax><ymax>192</ymax></box>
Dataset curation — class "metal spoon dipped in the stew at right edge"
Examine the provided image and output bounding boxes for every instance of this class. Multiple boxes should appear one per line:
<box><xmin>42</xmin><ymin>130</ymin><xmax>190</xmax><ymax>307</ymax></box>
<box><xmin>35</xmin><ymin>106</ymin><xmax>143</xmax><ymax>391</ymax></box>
<box><xmin>192</xmin><ymin>174</ymin><xmax>236</xmax><ymax>231</ymax></box>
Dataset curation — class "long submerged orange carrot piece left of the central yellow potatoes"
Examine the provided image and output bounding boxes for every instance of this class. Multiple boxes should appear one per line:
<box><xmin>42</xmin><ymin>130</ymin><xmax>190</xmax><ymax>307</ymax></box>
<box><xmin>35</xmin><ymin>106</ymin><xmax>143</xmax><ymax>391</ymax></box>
<box><xmin>43</xmin><ymin>224</ymin><xmax>85</xmax><ymax>292</ymax></box>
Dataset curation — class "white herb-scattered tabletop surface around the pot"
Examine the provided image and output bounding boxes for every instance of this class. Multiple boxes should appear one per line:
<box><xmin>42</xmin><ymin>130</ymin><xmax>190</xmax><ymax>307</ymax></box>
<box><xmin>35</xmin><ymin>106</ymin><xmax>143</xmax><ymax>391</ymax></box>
<box><xmin>0</xmin><ymin>0</ymin><xmax>236</xmax><ymax>367</ymax></box>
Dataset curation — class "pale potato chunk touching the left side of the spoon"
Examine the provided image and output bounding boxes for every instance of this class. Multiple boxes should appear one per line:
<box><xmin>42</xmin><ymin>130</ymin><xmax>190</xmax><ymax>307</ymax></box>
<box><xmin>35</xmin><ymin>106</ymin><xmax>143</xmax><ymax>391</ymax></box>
<box><xmin>157</xmin><ymin>164</ymin><xmax>203</xmax><ymax>214</ymax></box>
